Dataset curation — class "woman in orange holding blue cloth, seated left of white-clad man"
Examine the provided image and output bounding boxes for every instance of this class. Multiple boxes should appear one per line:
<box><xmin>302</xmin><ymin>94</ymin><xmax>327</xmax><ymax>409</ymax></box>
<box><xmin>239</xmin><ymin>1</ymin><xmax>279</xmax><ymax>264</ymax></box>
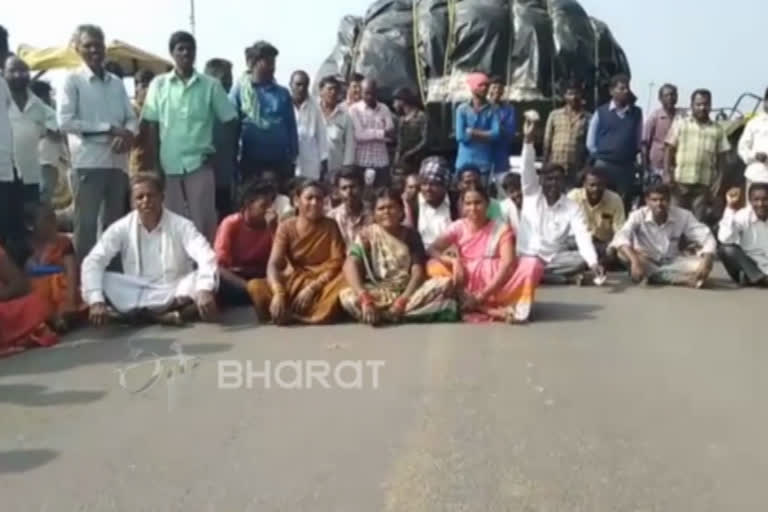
<box><xmin>24</xmin><ymin>205</ymin><xmax>87</xmax><ymax>332</ymax></box>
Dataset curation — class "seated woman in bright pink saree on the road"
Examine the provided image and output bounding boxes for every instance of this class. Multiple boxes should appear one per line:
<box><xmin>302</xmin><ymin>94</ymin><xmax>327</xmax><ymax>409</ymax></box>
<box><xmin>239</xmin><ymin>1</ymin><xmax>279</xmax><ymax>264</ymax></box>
<box><xmin>429</xmin><ymin>188</ymin><xmax>543</xmax><ymax>323</ymax></box>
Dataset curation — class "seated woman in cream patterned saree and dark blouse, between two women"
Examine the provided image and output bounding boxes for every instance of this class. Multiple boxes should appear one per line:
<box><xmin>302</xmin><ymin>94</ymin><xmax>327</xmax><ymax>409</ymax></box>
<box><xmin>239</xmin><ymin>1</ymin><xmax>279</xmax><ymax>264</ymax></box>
<box><xmin>339</xmin><ymin>189</ymin><xmax>458</xmax><ymax>325</ymax></box>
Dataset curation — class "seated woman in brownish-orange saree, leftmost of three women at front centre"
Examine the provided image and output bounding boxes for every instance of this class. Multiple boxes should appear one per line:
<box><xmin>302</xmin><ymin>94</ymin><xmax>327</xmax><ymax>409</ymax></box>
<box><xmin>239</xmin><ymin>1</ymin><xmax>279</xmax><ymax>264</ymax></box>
<box><xmin>248</xmin><ymin>181</ymin><xmax>344</xmax><ymax>324</ymax></box>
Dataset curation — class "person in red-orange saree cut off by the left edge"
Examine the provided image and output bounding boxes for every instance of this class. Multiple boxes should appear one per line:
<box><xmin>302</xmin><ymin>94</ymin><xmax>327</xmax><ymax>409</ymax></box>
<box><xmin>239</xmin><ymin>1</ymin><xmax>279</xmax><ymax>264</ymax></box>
<box><xmin>0</xmin><ymin>243</ymin><xmax>58</xmax><ymax>357</ymax></box>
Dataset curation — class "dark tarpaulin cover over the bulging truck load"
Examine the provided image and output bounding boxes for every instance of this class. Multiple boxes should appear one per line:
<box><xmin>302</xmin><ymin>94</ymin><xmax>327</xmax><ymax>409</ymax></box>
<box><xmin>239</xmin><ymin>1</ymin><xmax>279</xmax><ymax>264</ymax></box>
<box><xmin>319</xmin><ymin>0</ymin><xmax>629</xmax><ymax>103</ymax></box>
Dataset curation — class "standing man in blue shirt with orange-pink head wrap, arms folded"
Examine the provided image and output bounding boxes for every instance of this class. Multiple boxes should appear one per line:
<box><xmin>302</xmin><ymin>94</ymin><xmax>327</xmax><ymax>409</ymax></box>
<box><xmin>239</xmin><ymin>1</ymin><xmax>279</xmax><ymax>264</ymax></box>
<box><xmin>456</xmin><ymin>73</ymin><xmax>501</xmax><ymax>183</ymax></box>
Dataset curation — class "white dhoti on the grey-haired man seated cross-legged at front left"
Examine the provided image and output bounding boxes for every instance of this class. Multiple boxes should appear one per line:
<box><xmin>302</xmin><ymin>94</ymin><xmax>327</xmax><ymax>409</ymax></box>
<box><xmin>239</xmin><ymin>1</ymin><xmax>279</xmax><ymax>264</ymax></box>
<box><xmin>102</xmin><ymin>272</ymin><xmax>197</xmax><ymax>313</ymax></box>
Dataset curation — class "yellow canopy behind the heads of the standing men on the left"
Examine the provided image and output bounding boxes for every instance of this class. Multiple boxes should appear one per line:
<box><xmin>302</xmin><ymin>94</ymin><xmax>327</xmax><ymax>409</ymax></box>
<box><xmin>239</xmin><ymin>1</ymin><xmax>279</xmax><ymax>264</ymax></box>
<box><xmin>17</xmin><ymin>40</ymin><xmax>173</xmax><ymax>76</ymax></box>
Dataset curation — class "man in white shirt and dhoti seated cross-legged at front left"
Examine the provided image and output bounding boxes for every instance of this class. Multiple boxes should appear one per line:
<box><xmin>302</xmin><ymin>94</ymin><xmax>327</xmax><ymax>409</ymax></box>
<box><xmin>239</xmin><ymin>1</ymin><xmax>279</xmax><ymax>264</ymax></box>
<box><xmin>82</xmin><ymin>173</ymin><xmax>218</xmax><ymax>325</ymax></box>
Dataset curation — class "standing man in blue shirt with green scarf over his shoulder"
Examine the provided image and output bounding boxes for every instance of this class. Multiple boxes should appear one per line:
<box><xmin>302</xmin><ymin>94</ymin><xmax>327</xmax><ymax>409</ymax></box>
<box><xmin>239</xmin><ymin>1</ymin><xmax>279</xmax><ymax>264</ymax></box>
<box><xmin>229</xmin><ymin>41</ymin><xmax>299</xmax><ymax>190</ymax></box>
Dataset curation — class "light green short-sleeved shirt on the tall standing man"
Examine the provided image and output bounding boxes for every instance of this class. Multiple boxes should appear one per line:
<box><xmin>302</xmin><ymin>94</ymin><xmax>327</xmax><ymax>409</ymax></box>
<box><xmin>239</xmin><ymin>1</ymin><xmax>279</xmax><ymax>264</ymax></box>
<box><xmin>141</xmin><ymin>71</ymin><xmax>237</xmax><ymax>175</ymax></box>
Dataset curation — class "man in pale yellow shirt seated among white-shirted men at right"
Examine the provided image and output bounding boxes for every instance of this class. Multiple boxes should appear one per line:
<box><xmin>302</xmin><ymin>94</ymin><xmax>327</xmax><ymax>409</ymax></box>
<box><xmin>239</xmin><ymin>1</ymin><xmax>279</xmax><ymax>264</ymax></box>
<box><xmin>568</xmin><ymin>167</ymin><xmax>626</xmax><ymax>260</ymax></box>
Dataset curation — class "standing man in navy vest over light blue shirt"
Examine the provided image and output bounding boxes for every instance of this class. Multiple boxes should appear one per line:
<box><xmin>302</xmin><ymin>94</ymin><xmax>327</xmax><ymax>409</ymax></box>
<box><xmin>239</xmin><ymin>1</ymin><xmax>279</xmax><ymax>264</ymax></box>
<box><xmin>587</xmin><ymin>75</ymin><xmax>643</xmax><ymax>210</ymax></box>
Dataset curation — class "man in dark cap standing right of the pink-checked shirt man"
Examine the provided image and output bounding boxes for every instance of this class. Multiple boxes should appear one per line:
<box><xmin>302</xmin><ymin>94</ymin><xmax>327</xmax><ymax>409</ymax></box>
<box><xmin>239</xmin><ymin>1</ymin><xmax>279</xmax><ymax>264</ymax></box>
<box><xmin>394</xmin><ymin>87</ymin><xmax>427</xmax><ymax>174</ymax></box>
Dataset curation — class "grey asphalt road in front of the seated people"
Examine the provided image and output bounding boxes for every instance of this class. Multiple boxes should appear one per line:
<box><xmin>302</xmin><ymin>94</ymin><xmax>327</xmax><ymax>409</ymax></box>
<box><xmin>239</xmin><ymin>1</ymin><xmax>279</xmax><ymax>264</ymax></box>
<box><xmin>0</xmin><ymin>270</ymin><xmax>768</xmax><ymax>512</ymax></box>
